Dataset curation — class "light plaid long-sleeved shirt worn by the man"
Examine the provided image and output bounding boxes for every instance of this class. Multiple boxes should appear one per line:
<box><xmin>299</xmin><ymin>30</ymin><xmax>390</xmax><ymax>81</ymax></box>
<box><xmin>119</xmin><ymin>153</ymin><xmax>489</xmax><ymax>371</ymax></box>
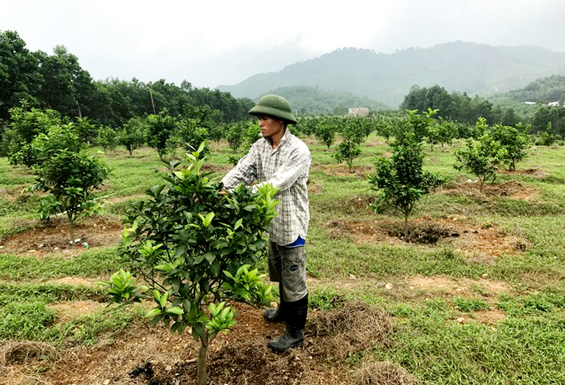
<box><xmin>222</xmin><ymin>128</ymin><xmax>311</xmax><ymax>246</ymax></box>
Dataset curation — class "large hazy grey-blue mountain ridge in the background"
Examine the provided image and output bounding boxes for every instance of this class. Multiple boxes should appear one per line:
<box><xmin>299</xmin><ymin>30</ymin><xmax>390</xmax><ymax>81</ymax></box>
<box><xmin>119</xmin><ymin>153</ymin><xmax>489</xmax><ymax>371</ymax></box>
<box><xmin>218</xmin><ymin>41</ymin><xmax>565</xmax><ymax>107</ymax></box>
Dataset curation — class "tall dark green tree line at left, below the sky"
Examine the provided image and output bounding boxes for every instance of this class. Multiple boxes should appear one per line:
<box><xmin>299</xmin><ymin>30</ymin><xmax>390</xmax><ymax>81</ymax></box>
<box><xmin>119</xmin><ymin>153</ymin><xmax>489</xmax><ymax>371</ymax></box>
<box><xmin>0</xmin><ymin>31</ymin><xmax>253</xmax><ymax>129</ymax></box>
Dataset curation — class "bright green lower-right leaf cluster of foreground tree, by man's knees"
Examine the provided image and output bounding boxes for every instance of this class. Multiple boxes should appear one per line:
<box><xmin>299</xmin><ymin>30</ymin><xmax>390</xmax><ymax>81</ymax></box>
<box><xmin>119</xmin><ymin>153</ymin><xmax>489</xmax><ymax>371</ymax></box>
<box><xmin>222</xmin><ymin>265</ymin><xmax>273</xmax><ymax>305</ymax></box>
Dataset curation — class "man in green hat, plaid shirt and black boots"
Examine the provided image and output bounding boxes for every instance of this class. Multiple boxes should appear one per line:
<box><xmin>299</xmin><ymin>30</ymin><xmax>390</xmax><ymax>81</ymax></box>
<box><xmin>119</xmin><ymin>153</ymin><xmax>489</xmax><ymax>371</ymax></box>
<box><xmin>222</xmin><ymin>95</ymin><xmax>311</xmax><ymax>352</ymax></box>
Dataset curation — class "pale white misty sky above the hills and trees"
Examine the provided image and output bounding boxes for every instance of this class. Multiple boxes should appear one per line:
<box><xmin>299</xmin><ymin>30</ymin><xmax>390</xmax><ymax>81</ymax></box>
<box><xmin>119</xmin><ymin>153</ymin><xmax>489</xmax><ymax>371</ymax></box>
<box><xmin>0</xmin><ymin>0</ymin><xmax>565</xmax><ymax>88</ymax></box>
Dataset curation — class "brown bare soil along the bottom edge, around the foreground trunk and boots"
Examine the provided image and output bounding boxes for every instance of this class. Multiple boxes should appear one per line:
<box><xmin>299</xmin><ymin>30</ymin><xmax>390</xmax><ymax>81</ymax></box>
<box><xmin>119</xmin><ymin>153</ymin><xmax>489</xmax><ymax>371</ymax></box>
<box><xmin>0</xmin><ymin>303</ymin><xmax>408</xmax><ymax>385</ymax></box>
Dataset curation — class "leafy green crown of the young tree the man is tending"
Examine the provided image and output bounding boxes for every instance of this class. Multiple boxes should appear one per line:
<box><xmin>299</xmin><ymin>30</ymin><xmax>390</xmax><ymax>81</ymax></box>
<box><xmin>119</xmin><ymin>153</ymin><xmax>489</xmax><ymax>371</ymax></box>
<box><xmin>122</xmin><ymin>144</ymin><xmax>278</xmax><ymax>380</ymax></box>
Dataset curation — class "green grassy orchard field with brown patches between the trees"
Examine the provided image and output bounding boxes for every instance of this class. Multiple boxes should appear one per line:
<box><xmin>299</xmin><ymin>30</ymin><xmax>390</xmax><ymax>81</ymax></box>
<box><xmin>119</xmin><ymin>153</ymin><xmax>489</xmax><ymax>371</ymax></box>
<box><xmin>0</xmin><ymin>136</ymin><xmax>565</xmax><ymax>385</ymax></box>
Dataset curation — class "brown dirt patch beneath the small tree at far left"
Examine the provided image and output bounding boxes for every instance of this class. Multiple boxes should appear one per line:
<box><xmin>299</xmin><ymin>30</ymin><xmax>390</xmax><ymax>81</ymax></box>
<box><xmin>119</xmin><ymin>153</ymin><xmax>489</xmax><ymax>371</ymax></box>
<box><xmin>0</xmin><ymin>215</ymin><xmax>124</xmax><ymax>255</ymax></box>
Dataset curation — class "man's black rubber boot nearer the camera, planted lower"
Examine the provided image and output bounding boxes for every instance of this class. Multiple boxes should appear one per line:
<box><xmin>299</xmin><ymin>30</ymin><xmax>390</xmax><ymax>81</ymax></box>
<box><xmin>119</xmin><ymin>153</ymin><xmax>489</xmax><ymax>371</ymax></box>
<box><xmin>267</xmin><ymin>294</ymin><xmax>308</xmax><ymax>353</ymax></box>
